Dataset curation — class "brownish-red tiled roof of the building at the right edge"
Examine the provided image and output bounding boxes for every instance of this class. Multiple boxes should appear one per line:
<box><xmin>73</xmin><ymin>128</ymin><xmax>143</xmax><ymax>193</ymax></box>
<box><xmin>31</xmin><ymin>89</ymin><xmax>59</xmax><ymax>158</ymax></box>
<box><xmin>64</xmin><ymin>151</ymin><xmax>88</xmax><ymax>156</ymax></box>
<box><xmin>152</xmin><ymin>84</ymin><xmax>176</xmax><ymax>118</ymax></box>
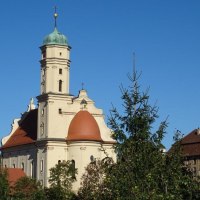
<box><xmin>181</xmin><ymin>129</ymin><xmax>200</xmax><ymax>156</ymax></box>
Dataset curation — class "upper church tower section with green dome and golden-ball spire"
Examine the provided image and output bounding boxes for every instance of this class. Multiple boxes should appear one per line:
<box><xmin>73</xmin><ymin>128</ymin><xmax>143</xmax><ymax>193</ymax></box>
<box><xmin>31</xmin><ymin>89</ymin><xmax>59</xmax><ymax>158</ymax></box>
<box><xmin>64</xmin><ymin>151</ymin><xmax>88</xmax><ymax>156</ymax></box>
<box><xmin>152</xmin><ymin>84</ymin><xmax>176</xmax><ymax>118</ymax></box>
<box><xmin>40</xmin><ymin>12</ymin><xmax>71</xmax><ymax>94</ymax></box>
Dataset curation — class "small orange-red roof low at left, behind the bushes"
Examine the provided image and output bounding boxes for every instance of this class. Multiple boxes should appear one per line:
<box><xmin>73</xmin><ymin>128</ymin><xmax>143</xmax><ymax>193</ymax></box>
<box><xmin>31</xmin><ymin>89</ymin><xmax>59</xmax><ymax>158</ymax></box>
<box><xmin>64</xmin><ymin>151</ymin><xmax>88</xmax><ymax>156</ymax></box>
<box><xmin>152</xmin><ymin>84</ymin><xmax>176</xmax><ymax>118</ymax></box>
<box><xmin>6</xmin><ymin>168</ymin><xmax>26</xmax><ymax>186</ymax></box>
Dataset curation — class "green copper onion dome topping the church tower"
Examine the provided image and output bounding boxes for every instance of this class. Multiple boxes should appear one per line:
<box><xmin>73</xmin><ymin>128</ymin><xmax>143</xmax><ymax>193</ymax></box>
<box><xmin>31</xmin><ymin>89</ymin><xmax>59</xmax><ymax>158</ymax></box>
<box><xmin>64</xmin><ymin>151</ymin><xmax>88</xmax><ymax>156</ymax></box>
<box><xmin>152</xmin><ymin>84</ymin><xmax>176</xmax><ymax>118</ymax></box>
<box><xmin>43</xmin><ymin>28</ymin><xmax>68</xmax><ymax>45</ymax></box>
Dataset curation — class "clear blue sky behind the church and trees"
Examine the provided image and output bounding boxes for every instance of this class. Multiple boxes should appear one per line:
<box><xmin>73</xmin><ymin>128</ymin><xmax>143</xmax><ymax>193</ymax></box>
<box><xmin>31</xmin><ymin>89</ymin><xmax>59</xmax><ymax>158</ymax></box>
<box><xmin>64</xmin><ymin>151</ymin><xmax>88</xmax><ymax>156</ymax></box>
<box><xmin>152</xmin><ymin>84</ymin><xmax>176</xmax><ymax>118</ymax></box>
<box><xmin>0</xmin><ymin>0</ymin><xmax>200</xmax><ymax>148</ymax></box>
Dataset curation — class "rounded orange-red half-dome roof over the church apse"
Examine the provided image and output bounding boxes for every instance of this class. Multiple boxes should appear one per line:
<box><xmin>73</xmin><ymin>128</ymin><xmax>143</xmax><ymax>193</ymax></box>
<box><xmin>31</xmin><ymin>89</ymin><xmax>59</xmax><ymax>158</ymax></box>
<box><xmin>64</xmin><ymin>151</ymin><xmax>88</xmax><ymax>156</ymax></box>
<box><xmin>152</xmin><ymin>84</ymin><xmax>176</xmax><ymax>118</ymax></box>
<box><xmin>67</xmin><ymin>110</ymin><xmax>102</xmax><ymax>141</ymax></box>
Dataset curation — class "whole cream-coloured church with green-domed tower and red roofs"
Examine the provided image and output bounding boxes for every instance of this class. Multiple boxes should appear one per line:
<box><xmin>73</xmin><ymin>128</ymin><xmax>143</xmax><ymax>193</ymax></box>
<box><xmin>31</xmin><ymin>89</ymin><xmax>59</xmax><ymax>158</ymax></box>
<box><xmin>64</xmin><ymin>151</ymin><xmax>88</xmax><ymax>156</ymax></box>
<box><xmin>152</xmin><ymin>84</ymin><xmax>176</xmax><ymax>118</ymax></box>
<box><xmin>0</xmin><ymin>13</ymin><xmax>116</xmax><ymax>191</ymax></box>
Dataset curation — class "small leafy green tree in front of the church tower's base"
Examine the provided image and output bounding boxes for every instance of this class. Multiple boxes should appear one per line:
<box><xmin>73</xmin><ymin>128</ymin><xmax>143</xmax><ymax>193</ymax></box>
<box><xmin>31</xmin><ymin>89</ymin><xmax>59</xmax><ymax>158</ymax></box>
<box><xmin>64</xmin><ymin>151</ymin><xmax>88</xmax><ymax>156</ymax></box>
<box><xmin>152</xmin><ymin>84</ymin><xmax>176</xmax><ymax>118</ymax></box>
<box><xmin>46</xmin><ymin>161</ymin><xmax>77</xmax><ymax>200</ymax></box>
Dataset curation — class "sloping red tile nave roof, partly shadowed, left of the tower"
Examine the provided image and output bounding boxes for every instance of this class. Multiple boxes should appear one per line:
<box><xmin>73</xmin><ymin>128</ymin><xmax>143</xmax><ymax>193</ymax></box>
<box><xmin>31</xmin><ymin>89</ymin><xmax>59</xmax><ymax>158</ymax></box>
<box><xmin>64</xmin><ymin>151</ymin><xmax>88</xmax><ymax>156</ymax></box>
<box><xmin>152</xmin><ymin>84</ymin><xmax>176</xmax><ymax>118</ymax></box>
<box><xmin>1</xmin><ymin>109</ymin><xmax>38</xmax><ymax>149</ymax></box>
